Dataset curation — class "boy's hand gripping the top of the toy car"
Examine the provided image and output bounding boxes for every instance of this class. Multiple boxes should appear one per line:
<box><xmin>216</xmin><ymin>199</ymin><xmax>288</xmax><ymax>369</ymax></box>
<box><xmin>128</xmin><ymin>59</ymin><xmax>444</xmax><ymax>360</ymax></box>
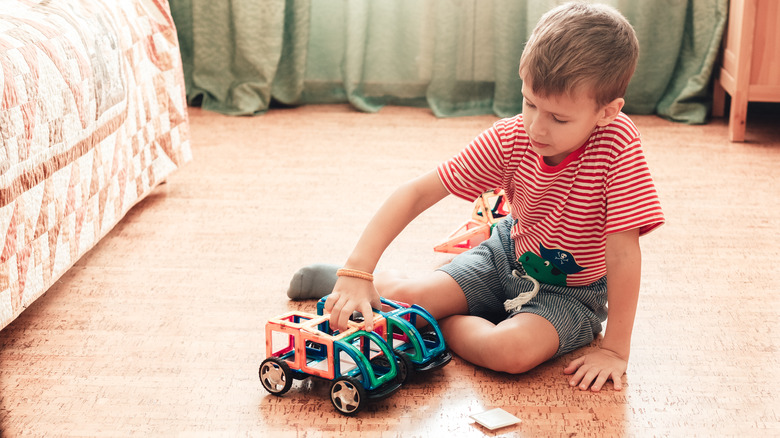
<box><xmin>325</xmin><ymin>277</ymin><xmax>381</xmax><ymax>331</ymax></box>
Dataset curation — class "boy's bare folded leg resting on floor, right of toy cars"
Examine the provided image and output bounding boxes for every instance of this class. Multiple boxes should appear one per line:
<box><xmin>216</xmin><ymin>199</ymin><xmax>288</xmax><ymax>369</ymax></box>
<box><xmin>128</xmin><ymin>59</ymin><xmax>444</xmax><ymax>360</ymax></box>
<box><xmin>439</xmin><ymin>313</ymin><xmax>559</xmax><ymax>374</ymax></box>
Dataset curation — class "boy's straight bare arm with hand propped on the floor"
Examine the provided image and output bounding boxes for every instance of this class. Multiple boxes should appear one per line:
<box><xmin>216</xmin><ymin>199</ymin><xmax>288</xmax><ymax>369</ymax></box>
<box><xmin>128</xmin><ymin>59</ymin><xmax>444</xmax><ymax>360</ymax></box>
<box><xmin>564</xmin><ymin>228</ymin><xmax>642</xmax><ymax>391</ymax></box>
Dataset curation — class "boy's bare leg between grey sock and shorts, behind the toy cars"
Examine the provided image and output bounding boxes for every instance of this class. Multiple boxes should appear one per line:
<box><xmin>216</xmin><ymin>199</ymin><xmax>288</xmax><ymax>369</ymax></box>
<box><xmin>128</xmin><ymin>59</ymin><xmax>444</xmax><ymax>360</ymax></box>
<box><xmin>374</xmin><ymin>271</ymin><xmax>469</xmax><ymax>320</ymax></box>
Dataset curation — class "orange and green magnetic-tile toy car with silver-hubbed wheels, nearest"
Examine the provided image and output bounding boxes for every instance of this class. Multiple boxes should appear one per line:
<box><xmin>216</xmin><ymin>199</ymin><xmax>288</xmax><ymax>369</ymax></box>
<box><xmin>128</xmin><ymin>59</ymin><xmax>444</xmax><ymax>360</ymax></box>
<box><xmin>259</xmin><ymin>311</ymin><xmax>412</xmax><ymax>415</ymax></box>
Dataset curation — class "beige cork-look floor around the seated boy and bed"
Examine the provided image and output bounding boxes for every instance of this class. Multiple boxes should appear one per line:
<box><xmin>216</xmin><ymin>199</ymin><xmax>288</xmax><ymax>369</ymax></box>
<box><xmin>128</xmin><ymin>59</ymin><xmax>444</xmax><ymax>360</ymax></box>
<box><xmin>0</xmin><ymin>102</ymin><xmax>780</xmax><ymax>437</ymax></box>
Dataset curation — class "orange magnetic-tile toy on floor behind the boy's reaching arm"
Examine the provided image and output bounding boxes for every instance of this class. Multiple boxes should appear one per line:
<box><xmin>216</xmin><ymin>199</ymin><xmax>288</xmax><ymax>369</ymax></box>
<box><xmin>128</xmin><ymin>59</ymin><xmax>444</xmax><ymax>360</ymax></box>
<box><xmin>433</xmin><ymin>190</ymin><xmax>509</xmax><ymax>254</ymax></box>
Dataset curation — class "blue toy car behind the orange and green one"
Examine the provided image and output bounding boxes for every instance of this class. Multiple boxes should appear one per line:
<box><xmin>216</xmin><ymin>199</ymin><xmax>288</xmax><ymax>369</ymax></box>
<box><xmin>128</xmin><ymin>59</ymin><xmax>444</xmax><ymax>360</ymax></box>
<box><xmin>317</xmin><ymin>297</ymin><xmax>452</xmax><ymax>374</ymax></box>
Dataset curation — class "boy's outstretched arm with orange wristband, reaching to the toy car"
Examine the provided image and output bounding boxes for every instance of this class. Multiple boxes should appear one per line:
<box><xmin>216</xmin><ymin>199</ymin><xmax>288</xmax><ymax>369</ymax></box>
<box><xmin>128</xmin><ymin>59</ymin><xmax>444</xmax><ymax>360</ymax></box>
<box><xmin>325</xmin><ymin>170</ymin><xmax>449</xmax><ymax>330</ymax></box>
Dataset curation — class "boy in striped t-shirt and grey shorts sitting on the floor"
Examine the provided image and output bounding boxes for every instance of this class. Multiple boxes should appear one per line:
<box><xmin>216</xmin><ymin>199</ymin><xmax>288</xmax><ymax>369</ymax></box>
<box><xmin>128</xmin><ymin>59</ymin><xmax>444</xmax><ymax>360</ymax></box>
<box><xmin>288</xmin><ymin>3</ymin><xmax>664</xmax><ymax>391</ymax></box>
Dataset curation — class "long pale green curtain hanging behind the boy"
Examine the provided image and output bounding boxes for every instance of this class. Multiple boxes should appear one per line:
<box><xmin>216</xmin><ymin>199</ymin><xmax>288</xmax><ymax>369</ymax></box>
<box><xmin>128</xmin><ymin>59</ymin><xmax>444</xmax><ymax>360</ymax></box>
<box><xmin>170</xmin><ymin>0</ymin><xmax>728</xmax><ymax>123</ymax></box>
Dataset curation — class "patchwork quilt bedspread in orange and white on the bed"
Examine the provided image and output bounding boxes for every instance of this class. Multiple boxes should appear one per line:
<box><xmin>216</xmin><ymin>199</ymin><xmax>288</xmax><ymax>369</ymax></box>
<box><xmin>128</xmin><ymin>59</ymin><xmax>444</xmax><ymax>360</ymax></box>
<box><xmin>0</xmin><ymin>0</ymin><xmax>191</xmax><ymax>328</ymax></box>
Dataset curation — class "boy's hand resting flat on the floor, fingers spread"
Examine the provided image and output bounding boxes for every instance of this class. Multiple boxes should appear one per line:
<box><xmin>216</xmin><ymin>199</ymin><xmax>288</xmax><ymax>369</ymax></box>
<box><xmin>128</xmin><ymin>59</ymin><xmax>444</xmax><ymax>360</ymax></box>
<box><xmin>563</xmin><ymin>348</ymin><xmax>628</xmax><ymax>392</ymax></box>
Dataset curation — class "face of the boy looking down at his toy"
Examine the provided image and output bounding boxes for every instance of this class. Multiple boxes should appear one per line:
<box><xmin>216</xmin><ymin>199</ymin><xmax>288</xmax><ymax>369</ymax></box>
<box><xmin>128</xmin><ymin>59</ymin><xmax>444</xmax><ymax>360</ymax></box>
<box><xmin>522</xmin><ymin>80</ymin><xmax>622</xmax><ymax>166</ymax></box>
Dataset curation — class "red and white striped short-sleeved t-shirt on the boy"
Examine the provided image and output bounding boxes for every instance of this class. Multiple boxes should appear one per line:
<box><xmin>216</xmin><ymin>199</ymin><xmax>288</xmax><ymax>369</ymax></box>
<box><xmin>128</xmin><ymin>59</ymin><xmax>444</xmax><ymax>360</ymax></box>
<box><xmin>438</xmin><ymin>113</ymin><xmax>664</xmax><ymax>286</ymax></box>
